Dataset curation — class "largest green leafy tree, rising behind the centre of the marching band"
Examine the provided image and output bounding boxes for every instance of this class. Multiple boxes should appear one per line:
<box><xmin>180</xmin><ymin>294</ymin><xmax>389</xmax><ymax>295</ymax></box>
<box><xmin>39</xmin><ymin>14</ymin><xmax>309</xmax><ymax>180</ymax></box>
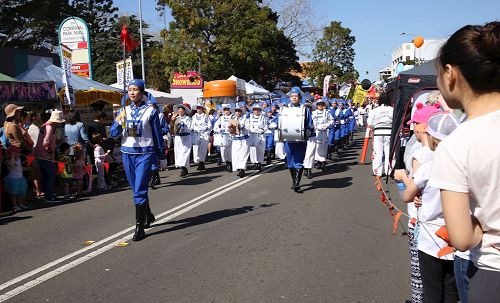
<box><xmin>159</xmin><ymin>0</ymin><xmax>300</xmax><ymax>87</ymax></box>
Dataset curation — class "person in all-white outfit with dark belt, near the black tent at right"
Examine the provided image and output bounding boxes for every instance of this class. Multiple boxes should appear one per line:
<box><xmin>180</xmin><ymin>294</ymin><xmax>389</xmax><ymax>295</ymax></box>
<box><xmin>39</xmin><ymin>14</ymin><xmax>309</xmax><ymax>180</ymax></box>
<box><xmin>367</xmin><ymin>94</ymin><xmax>394</xmax><ymax>176</ymax></box>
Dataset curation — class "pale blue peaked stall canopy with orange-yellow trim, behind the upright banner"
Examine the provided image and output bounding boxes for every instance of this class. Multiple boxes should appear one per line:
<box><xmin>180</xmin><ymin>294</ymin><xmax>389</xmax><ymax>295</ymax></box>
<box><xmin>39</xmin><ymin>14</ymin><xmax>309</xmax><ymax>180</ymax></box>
<box><xmin>16</xmin><ymin>59</ymin><xmax>122</xmax><ymax>106</ymax></box>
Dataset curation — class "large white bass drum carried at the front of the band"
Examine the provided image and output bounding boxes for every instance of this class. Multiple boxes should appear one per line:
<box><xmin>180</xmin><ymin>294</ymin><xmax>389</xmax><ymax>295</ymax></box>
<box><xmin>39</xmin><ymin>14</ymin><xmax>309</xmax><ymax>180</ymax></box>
<box><xmin>278</xmin><ymin>106</ymin><xmax>306</xmax><ymax>141</ymax></box>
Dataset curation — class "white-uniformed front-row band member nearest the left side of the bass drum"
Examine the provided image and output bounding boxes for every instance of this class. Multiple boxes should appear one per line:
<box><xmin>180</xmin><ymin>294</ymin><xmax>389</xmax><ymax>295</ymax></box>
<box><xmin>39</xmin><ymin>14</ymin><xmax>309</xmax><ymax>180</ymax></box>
<box><xmin>248</xmin><ymin>103</ymin><xmax>268</xmax><ymax>170</ymax></box>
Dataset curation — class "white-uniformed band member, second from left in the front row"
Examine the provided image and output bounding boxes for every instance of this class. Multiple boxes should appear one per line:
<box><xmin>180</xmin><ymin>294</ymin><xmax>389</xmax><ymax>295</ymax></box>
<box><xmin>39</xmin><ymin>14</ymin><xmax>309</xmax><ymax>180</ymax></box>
<box><xmin>191</xmin><ymin>104</ymin><xmax>212</xmax><ymax>170</ymax></box>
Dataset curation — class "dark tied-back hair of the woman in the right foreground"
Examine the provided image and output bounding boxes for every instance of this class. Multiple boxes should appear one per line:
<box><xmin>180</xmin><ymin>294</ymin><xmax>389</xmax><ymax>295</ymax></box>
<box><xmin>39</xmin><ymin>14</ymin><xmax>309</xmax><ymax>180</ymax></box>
<box><xmin>438</xmin><ymin>22</ymin><xmax>500</xmax><ymax>93</ymax></box>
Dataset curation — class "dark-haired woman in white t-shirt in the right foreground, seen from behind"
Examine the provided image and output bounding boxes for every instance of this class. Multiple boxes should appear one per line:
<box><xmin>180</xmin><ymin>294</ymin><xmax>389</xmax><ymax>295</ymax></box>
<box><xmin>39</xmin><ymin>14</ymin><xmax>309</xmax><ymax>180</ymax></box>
<box><xmin>429</xmin><ymin>22</ymin><xmax>500</xmax><ymax>302</ymax></box>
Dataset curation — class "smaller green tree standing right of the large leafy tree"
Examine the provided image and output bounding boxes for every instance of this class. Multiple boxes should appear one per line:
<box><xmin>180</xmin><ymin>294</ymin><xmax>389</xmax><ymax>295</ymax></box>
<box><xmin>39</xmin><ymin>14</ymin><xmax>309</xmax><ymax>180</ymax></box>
<box><xmin>306</xmin><ymin>21</ymin><xmax>359</xmax><ymax>84</ymax></box>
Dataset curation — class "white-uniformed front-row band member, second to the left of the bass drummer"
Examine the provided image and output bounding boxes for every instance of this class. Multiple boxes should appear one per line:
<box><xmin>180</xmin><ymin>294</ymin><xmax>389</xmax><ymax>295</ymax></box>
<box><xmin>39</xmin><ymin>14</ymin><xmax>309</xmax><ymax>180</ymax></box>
<box><xmin>229</xmin><ymin>107</ymin><xmax>250</xmax><ymax>178</ymax></box>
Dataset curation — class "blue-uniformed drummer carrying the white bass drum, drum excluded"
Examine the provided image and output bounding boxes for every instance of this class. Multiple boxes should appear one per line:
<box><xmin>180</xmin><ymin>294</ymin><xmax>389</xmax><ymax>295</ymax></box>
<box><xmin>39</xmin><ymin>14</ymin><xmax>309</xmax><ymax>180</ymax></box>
<box><xmin>285</xmin><ymin>87</ymin><xmax>313</xmax><ymax>193</ymax></box>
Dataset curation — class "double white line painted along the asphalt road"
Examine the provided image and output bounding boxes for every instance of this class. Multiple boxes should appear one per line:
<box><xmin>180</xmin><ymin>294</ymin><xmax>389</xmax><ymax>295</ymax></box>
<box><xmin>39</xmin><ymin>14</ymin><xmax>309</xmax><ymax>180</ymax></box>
<box><xmin>0</xmin><ymin>164</ymin><xmax>277</xmax><ymax>302</ymax></box>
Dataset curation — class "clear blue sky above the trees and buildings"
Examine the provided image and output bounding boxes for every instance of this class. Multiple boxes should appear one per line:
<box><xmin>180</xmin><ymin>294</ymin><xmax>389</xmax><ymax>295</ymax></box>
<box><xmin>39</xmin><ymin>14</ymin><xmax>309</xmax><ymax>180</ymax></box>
<box><xmin>114</xmin><ymin>0</ymin><xmax>500</xmax><ymax>80</ymax></box>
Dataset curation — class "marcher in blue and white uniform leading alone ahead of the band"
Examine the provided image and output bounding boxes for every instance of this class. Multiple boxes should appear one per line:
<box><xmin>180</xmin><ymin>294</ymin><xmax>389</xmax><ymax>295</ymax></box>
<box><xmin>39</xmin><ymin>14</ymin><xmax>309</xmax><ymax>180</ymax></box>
<box><xmin>110</xmin><ymin>79</ymin><xmax>164</xmax><ymax>241</ymax></box>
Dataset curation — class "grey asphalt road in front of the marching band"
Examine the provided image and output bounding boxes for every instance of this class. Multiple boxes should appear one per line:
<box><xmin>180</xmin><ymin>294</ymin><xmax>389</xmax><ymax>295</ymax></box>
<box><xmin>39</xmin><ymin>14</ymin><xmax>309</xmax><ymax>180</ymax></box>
<box><xmin>0</xmin><ymin>134</ymin><xmax>410</xmax><ymax>302</ymax></box>
